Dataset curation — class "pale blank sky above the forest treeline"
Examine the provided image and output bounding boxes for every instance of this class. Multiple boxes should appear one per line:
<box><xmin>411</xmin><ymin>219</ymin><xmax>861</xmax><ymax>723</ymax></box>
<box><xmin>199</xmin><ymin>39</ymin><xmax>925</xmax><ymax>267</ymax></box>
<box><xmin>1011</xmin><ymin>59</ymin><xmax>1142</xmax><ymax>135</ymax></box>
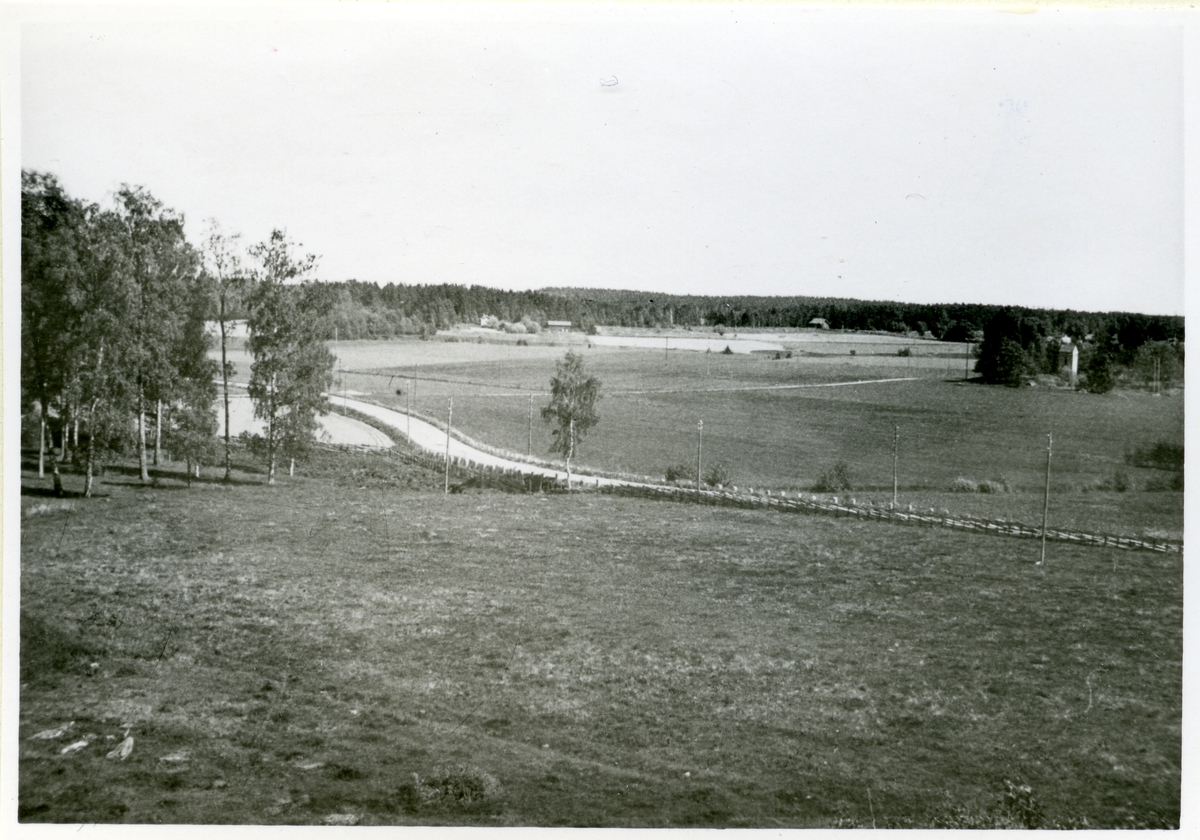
<box><xmin>11</xmin><ymin>4</ymin><xmax>1183</xmax><ymax>313</ymax></box>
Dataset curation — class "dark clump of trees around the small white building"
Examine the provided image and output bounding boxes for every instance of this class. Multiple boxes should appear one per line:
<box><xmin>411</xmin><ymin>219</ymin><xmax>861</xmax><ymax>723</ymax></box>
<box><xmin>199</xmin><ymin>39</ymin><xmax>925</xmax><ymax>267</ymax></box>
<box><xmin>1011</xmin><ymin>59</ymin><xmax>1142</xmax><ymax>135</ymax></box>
<box><xmin>976</xmin><ymin>308</ymin><xmax>1183</xmax><ymax>394</ymax></box>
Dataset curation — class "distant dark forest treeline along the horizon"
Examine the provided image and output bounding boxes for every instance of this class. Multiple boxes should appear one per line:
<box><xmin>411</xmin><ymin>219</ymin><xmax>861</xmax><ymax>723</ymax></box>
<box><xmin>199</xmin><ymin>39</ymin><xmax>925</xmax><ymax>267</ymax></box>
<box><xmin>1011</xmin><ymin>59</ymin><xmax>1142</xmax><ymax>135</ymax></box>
<box><xmin>278</xmin><ymin>281</ymin><xmax>1183</xmax><ymax>361</ymax></box>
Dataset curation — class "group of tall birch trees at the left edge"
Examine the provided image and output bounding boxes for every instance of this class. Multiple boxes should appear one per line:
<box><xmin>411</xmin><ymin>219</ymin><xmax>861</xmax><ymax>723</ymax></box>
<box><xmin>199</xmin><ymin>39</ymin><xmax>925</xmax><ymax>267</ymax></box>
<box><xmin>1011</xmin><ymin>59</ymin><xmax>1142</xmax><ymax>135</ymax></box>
<box><xmin>20</xmin><ymin>172</ymin><xmax>332</xmax><ymax>494</ymax></box>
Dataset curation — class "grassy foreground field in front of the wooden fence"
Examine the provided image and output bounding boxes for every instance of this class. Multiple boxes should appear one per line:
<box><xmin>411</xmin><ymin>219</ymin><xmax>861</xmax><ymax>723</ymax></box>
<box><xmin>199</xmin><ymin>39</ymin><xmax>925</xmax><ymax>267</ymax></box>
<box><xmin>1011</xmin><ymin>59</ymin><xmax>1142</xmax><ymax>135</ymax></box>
<box><xmin>19</xmin><ymin>456</ymin><xmax>1182</xmax><ymax>827</ymax></box>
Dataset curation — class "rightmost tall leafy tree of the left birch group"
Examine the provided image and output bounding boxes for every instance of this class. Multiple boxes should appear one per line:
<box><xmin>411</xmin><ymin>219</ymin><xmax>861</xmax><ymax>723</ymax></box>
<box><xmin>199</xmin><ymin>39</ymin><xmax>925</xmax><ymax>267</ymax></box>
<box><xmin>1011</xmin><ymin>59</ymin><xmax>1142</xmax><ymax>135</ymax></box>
<box><xmin>247</xmin><ymin>230</ymin><xmax>334</xmax><ymax>484</ymax></box>
